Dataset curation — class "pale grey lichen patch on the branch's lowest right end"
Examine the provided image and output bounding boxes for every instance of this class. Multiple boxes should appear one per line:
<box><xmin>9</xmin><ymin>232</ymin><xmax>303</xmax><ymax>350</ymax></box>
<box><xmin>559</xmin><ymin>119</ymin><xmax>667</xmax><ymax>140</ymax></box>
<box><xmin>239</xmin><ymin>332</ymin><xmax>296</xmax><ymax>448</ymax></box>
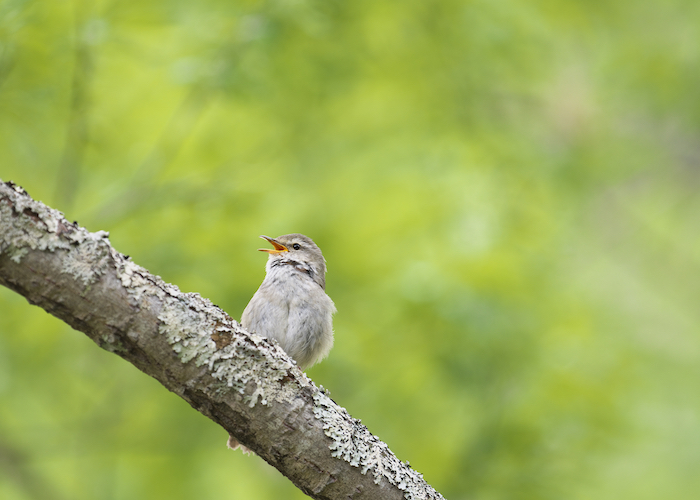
<box><xmin>313</xmin><ymin>390</ymin><xmax>443</xmax><ymax>500</ymax></box>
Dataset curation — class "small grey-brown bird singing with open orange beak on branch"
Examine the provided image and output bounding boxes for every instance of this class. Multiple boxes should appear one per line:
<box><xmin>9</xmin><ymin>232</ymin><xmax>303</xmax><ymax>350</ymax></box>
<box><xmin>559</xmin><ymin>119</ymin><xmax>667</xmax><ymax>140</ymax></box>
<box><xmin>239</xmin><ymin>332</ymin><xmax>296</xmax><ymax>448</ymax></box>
<box><xmin>227</xmin><ymin>233</ymin><xmax>336</xmax><ymax>453</ymax></box>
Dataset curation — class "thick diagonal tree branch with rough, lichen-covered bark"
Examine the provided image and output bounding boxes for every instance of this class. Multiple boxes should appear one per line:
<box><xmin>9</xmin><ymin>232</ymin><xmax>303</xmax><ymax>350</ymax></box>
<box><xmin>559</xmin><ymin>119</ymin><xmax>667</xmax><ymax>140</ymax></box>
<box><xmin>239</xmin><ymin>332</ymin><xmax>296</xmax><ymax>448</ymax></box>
<box><xmin>0</xmin><ymin>181</ymin><xmax>442</xmax><ymax>499</ymax></box>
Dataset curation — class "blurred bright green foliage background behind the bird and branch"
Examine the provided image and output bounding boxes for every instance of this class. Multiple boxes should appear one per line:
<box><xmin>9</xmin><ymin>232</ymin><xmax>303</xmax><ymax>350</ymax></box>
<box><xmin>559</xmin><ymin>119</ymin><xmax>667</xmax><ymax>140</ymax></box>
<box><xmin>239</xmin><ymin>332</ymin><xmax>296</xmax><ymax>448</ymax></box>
<box><xmin>0</xmin><ymin>0</ymin><xmax>700</xmax><ymax>500</ymax></box>
